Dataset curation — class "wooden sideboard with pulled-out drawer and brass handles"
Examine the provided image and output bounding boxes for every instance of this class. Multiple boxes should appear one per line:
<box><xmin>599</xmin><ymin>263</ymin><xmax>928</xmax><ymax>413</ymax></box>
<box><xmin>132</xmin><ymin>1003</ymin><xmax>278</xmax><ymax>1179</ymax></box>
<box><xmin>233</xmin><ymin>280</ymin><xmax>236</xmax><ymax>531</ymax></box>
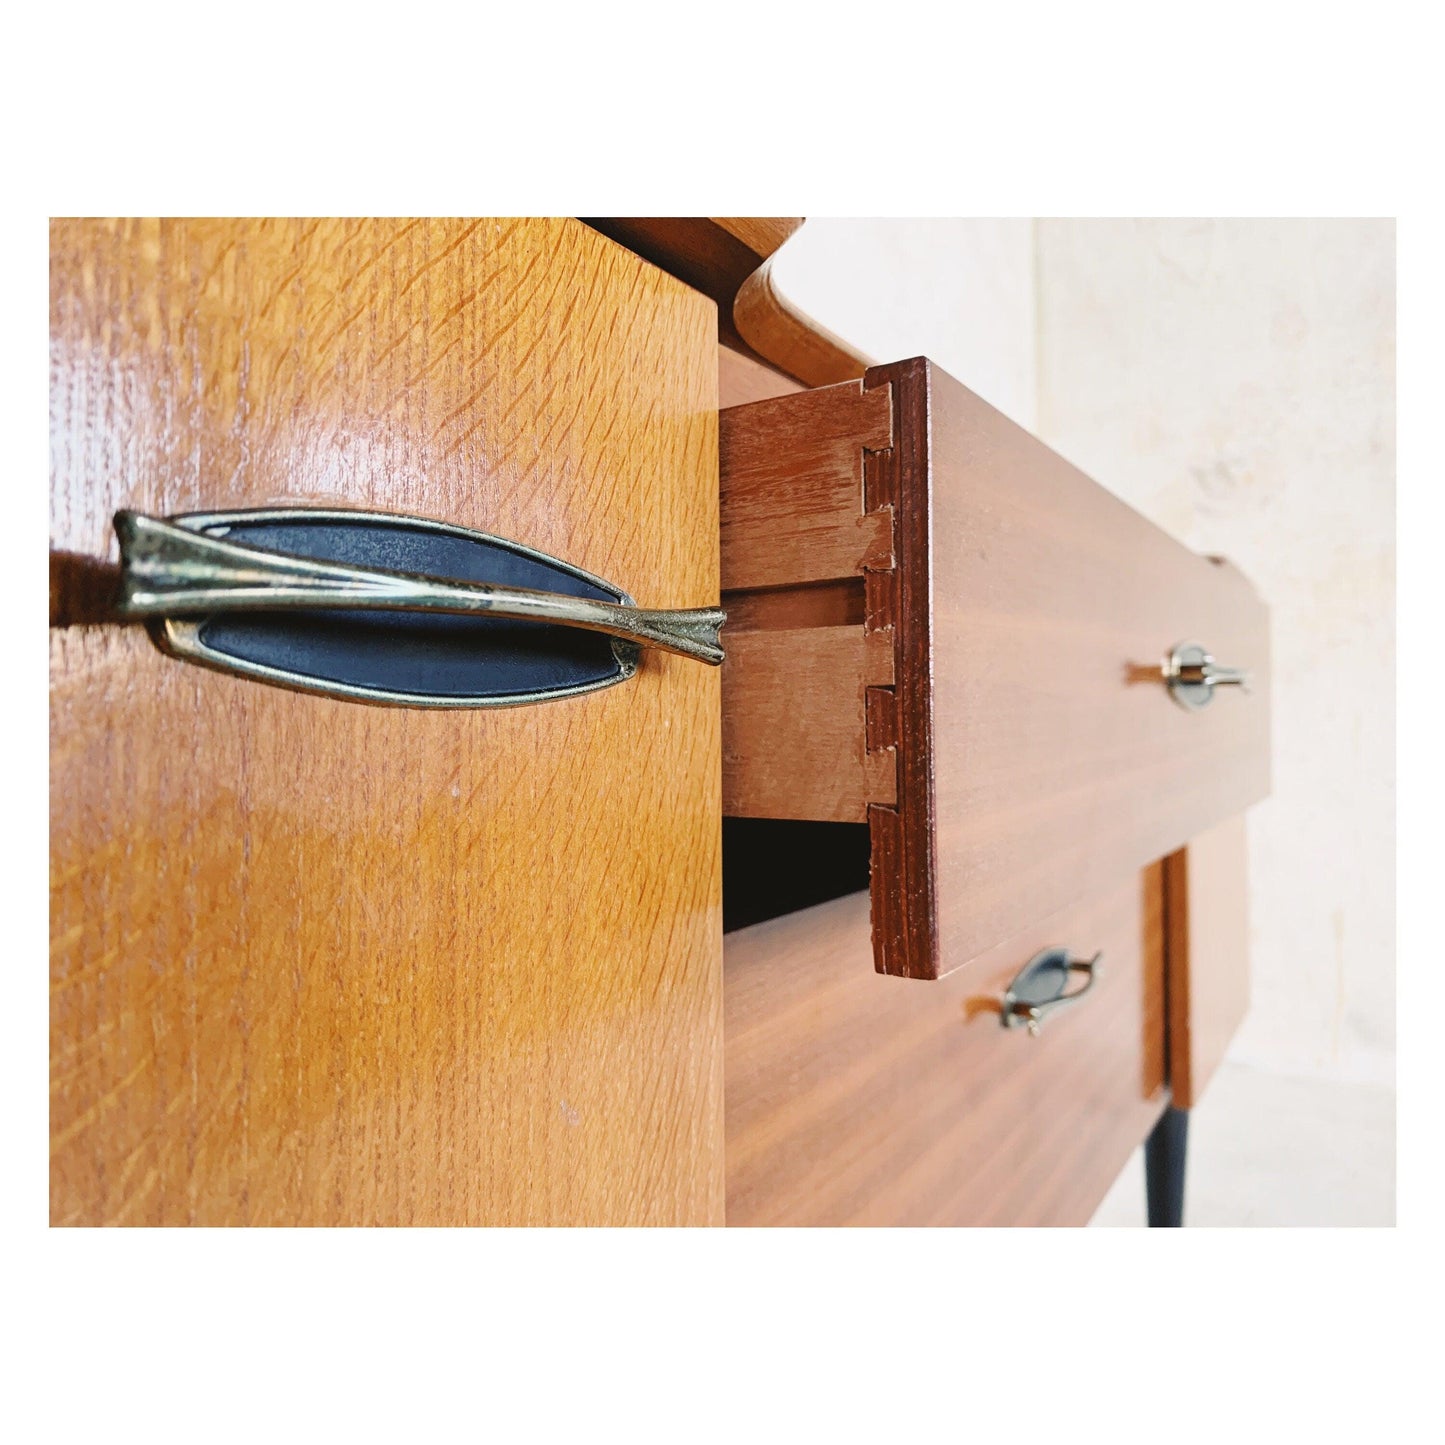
<box><xmin>51</xmin><ymin>218</ymin><xmax>1269</xmax><ymax>1225</ymax></box>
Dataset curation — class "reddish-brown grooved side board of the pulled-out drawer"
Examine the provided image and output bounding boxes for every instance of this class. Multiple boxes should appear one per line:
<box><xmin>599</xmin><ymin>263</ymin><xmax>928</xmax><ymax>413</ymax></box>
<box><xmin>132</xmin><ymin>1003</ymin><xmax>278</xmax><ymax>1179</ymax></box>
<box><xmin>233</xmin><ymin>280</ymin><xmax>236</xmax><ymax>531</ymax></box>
<box><xmin>720</xmin><ymin>383</ymin><xmax>897</xmax><ymax>822</ymax></box>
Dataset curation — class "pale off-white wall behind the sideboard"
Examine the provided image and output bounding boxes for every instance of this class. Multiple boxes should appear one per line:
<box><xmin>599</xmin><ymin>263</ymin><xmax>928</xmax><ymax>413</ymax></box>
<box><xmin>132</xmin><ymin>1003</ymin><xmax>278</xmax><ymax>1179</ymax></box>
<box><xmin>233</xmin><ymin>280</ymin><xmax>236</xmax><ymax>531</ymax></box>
<box><xmin>776</xmin><ymin>220</ymin><xmax>1394</xmax><ymax>1224</ymax></box>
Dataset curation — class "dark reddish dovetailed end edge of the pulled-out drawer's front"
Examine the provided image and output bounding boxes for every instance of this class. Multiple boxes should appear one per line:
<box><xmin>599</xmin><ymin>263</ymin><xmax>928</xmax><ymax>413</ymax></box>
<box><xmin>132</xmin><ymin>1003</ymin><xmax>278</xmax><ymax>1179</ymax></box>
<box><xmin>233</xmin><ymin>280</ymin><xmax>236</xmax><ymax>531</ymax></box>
<box><xmin>863</xmin><ymin>357</ymin><xmax>948</xmax><ymax>978</ymax></box>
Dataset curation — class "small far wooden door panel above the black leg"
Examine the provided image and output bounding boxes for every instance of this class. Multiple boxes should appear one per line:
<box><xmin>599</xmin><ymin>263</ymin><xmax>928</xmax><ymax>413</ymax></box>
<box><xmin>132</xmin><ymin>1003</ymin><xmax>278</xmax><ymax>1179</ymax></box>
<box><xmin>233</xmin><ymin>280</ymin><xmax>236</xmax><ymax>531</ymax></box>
<box><xmin>1165</xmin><ymin>816</ymin><xmax>1250</xmax><ymax>1108</ymax></box>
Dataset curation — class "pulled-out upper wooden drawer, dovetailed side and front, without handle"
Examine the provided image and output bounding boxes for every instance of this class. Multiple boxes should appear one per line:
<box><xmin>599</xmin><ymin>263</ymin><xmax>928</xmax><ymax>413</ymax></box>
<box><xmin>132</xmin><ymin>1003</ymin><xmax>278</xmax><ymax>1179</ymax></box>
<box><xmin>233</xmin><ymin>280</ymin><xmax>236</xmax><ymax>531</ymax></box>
<box><xmin>721</xmin><ymin>360</ymin><xmax>1269</xmax><ymax>978</ymax></box>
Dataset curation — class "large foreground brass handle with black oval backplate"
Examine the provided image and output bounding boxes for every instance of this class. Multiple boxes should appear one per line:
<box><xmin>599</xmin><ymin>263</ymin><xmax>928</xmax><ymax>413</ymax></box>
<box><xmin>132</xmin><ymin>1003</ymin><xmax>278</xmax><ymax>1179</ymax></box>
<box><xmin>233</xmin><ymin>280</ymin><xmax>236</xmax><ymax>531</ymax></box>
<box><xmin>116</xmin><ymin>507</ymin><xmax>727</xmax><ymax>707</ymax></box>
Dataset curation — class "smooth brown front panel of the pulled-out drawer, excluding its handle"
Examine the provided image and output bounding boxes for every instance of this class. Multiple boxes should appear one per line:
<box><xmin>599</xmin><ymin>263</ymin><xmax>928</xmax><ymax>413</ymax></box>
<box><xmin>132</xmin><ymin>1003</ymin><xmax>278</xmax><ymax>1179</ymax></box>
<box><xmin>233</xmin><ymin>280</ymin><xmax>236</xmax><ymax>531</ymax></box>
<box><xmin>901</xmin><ymin>361</ymin><xmax>1270</xmax><ymax>975</ymax></box>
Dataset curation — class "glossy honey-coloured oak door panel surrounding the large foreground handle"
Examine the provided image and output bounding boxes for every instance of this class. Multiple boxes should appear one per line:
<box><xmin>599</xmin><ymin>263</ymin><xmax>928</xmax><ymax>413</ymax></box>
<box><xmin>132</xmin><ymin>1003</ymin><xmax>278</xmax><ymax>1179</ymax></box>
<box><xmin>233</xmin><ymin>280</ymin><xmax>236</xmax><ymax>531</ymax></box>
<box><xmin>51</xmin><ymin>220</ymin><xmax>723</xmax><ymax>1224</ymax></box>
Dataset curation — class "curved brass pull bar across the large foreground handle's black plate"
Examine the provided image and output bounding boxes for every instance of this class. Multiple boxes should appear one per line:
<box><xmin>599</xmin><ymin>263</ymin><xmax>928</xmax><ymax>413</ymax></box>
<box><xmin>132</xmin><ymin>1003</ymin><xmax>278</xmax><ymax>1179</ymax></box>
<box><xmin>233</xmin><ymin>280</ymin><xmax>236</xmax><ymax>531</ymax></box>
<box><xmin>116</xmin><ymin>510</ymin><xmax>727</xmax><ymax>668</ymax></box>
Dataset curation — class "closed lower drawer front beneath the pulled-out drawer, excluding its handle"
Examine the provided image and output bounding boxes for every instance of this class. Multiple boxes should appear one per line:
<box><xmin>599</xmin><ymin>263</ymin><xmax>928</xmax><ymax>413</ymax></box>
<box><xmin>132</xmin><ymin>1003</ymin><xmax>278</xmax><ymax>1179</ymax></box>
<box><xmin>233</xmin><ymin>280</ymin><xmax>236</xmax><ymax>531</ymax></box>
<box><xmin>724</xmin><ymin>864</ymin><xmax>1166</xmax><ymax>1225</ymax></box>
